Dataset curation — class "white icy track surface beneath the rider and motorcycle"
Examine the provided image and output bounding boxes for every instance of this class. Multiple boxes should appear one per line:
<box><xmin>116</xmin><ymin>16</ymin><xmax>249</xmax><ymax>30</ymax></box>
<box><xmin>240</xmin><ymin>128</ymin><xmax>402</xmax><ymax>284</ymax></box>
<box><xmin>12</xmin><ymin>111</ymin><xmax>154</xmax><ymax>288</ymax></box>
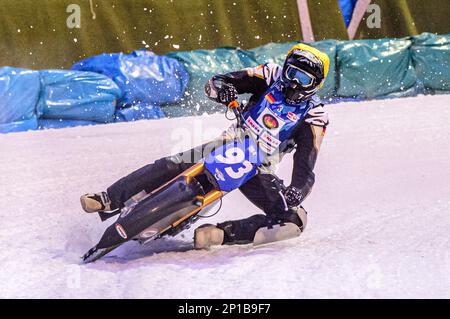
<box><xmin>0</xmin><ymin>95</ymin><xmax>450</xmax><ymax>298</ymax></box>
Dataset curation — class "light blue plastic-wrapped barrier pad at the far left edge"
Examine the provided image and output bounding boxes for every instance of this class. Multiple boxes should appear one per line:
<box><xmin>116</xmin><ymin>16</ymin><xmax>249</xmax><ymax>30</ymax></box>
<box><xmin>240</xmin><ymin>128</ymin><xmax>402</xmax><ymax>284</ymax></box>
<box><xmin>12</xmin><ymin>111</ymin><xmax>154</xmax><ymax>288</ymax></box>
<box><xmin>0</xmin><ymin>67</ymin><xmax>41</xmax><ymax>127</ymax></box>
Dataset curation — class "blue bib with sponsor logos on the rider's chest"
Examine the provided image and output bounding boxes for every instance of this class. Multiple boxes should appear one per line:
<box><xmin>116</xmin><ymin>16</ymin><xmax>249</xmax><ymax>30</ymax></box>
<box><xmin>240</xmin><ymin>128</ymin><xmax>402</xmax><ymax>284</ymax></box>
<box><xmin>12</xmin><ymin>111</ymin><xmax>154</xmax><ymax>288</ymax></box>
<box><xmin>243</xmin><ymin>80</ymin><xmax>313</xmax><ymax>155</ymax></box>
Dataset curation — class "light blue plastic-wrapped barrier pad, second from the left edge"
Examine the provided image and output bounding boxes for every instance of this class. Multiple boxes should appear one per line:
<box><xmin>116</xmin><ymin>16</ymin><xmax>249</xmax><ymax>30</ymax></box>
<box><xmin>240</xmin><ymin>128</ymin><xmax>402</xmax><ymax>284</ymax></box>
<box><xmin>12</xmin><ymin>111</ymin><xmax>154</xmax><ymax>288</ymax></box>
<box><xmin>38</xmin><ymin>70</ymin><xmax>121</xmax><ymax>123</ymax></box>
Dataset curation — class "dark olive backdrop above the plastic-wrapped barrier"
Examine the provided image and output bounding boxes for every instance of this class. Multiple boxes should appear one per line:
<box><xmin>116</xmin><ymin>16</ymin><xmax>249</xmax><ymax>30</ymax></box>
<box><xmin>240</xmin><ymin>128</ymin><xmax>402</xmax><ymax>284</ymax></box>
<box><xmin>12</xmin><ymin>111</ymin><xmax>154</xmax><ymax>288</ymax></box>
<box><xmin>0</xmin><ymin>0</ymin><xmax>450</xmax><ymax>69</ymax></box>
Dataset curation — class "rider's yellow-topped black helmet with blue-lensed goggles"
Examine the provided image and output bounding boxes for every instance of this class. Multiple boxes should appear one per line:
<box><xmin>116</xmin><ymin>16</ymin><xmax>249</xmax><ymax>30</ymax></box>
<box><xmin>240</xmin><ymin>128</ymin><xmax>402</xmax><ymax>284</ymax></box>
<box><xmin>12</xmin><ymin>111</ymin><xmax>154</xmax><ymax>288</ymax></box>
<box><xmin>281</xmin><ymin>43</ymin><xmax>330</xmax><ymax>104</ymax></box>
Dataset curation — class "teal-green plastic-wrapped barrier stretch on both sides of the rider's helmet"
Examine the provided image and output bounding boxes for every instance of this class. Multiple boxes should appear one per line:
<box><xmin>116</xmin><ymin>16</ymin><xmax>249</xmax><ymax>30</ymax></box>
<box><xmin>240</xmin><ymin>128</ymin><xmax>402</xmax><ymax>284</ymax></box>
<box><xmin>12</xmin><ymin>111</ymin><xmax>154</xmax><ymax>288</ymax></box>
<box><xmin>164</xmin><ymin>33</ymin><xmax>450</xmax><ymax>116</ymax></box>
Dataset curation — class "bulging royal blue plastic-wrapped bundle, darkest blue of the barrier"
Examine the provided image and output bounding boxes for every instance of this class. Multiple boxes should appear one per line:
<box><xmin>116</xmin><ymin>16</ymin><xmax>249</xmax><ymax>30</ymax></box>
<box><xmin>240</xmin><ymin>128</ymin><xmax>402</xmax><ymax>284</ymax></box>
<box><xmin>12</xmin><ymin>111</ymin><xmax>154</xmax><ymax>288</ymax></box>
<box><xmin>72</xmin><ymin>50</ymin><xmax>189</xmax><ymax>106</ymax></box>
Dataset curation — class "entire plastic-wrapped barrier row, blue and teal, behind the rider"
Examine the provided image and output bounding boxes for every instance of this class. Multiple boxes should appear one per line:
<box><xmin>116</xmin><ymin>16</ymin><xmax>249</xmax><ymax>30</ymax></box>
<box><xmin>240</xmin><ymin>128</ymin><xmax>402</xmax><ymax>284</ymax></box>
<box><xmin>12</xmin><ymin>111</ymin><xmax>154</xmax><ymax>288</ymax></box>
<box><xmin>0</xmin><ymin>33</ymin><xmax>450</xmax><ymax>133</ymax></box>
